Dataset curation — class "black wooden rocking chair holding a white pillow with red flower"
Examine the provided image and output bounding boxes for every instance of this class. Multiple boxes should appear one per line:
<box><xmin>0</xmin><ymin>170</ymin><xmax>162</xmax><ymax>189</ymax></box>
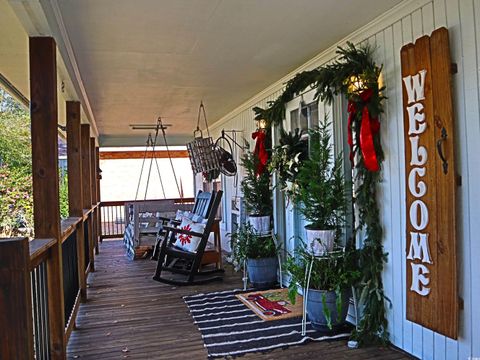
<box><xmin>153</xmin><ymin>191</ymin><xmax>223</xmax><ymax>285</ymax></box>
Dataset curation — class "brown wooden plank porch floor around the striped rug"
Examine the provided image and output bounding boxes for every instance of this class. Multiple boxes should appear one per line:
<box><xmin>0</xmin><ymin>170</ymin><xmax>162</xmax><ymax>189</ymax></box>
<box><xmin>68</xmin><ymin>240</ymin><xmax>409</xmax><ymax>360</ymax></box>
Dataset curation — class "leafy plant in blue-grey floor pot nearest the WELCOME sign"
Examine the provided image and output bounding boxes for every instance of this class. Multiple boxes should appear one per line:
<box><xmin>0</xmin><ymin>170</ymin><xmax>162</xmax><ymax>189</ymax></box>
<box><xmin>285</xmin><ymin>245</ymin><xmax>361</xmax><ymax>332</ymax></box>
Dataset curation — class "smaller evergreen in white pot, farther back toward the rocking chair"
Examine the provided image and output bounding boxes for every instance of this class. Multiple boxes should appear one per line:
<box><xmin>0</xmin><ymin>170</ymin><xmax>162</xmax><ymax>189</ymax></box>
<box><xmin>242</xmin><ymin>151</ymin><xmax>273</xmax><ymax>235</ymax></box>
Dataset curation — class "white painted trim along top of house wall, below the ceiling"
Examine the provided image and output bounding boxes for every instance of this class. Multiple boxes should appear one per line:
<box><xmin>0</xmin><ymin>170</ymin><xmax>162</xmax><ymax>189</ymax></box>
<box><xmin>210</xmin><ymin>0</ymin><xmax>432</xmax><ymax>129</ymax></box>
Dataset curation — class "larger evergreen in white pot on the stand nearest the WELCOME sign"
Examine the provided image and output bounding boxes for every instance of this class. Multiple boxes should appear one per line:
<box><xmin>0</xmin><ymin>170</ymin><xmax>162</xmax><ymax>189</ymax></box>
<box><xmin>293</xmin><ymin>119</ymin><xmax>347</xmax><ymax>255</ymax></box>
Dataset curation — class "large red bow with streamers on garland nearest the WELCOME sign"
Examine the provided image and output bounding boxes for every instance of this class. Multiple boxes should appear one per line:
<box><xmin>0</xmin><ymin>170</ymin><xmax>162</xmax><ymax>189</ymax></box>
<box><xmin>348</xmin><ymin>89</ymin><xmax>380</xmax><ymax>171</ymax></box>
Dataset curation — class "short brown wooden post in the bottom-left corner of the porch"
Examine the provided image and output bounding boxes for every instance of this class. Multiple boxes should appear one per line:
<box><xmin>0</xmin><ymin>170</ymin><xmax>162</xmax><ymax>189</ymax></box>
<box><xmin>0</xmin><ymin>238</ymin><xmax>33</xmax><ymax>360</ymax></box>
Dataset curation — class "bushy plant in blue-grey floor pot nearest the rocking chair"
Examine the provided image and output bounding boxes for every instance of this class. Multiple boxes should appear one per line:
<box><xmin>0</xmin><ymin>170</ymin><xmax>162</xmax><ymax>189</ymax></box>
<box><xmin>230</xmin><ymin>223</ymin><xmax>278</xmax><ymax>289</ymax></box>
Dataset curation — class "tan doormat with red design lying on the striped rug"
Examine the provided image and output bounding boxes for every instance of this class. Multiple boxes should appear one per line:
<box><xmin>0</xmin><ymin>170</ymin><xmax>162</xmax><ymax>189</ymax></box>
<box><xmin>235</xmin><ymin>288</ymin><xmax>303</xmax><ymax>321</ymax></box>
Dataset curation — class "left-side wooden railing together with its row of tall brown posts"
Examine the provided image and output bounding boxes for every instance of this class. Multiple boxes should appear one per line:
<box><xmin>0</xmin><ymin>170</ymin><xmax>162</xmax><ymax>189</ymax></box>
<box><xmin>0</xmin><ymin>36</ymin><xmax>100</xmax><ymax>360</ymax></box>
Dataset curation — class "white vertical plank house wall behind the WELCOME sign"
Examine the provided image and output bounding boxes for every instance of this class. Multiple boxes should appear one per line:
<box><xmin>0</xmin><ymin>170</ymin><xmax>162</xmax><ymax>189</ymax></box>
<box><xmin>212</xmin><ymin>0</ymin><xmax>480</xmax><ymax>360</ymax></box>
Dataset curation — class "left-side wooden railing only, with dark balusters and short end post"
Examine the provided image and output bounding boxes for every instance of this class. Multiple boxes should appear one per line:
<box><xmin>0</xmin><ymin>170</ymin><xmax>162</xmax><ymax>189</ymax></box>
<box><xmin>0</xmin><ymin>206</ymin><xmax>99</xmax><ymax>359</ymax></box>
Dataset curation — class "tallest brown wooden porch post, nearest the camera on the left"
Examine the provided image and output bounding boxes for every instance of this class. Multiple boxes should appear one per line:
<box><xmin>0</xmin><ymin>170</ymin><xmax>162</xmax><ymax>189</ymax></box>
<box><xmin>30</xmin><ymin>37</ymin><xmax>66</xmax><ymax>359</ymax></box>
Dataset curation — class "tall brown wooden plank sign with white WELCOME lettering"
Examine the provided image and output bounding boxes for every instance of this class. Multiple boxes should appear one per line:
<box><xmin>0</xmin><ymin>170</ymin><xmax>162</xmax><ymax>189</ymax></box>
<box><xmin>400</xmin><ymin>28</ymin><xmax>458</xmax><ymax>339</ymax></box>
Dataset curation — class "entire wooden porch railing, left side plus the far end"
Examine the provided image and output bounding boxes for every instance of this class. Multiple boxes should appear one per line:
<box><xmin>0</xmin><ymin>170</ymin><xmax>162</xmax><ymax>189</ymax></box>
<box><xmin>0</xmin><ymin>198</ymin><xmax>197</xmax><ymax>359</ymax></box>
